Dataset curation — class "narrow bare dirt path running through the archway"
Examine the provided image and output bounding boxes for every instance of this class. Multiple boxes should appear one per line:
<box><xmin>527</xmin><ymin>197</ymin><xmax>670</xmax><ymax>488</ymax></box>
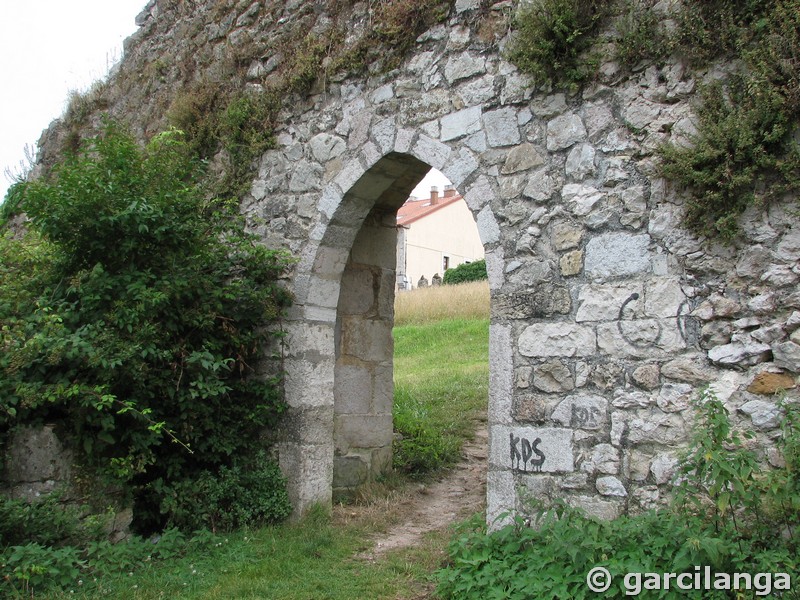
<box><xmin>361</xmin><ymin>423</ymin><xmax>488</xmax><ymax>560</ymax></box>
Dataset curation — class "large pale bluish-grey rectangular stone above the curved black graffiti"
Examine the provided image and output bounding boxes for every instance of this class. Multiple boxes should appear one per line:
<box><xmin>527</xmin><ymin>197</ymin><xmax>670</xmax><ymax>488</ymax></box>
<box><xmin>584</xmin><ymin>233</ymin><xmax>650</xmax><ymax>279</ymax></box>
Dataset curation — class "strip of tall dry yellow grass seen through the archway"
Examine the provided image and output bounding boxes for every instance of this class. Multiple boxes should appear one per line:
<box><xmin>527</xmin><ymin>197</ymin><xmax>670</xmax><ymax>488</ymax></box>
<box><xmin>394</xmin><ymin>280</ymin><xmax>489</xmax><ymax>325</ymax></box>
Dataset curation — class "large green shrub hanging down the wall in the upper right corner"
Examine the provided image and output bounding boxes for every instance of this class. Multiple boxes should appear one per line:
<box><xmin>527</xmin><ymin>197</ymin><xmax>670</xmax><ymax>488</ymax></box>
<box><xmin>661</xmin><ymin>0</ymin><xmax>800</xmax><ymax>239</ymax></box>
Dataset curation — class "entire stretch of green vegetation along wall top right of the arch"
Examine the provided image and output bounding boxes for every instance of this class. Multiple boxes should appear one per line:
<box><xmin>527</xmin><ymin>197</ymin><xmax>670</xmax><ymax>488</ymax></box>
<box><xmin>508</xmin><ymin>0</ymin><xmax>800</xmax><ymax>239</ymax></box>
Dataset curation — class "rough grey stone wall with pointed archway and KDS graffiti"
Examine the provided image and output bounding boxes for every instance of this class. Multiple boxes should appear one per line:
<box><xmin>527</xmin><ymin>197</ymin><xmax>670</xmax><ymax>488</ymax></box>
<box><xmin>26</xmin><ymin>0</ymin><xmax>800</xmax><ymax>521</ymax></box>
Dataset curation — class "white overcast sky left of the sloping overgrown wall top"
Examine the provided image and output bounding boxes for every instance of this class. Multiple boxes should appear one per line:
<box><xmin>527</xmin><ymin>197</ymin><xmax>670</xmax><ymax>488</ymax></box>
<box><xmin>0</xmin><ymin>0</ymin><xmax>147</xmax><ymax>201</ymax></box>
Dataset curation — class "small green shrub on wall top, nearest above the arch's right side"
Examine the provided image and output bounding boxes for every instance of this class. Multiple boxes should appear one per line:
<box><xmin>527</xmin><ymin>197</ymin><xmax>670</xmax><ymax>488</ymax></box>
<box><xmin>508</xmin><ymin>0</ymin><xmax>612</xmax><ymax>87</ymax></box>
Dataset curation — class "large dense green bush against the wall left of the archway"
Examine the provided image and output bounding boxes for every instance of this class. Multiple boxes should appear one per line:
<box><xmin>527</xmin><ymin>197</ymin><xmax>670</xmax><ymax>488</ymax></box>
<box><xmin>0</xmin><ymin>123</ymin><xmax>289</xmax><ymax>528</ymax></box>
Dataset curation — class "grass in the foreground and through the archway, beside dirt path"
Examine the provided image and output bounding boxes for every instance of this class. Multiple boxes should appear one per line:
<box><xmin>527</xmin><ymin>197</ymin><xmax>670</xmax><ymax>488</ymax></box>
<box><xmin>15</xmin><ymin>282</ymin><xmax>489</xmax><ymax>600</ymax></box>
